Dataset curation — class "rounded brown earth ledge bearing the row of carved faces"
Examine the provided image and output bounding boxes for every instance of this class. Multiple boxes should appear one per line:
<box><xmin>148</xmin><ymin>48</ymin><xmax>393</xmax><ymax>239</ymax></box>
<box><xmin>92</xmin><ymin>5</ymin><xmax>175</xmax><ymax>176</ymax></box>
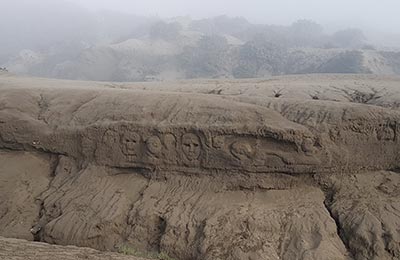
<box><xmin>0</xmin><ymin>83</ymin><xmax>400</xmax><ymax>174</ymax></box>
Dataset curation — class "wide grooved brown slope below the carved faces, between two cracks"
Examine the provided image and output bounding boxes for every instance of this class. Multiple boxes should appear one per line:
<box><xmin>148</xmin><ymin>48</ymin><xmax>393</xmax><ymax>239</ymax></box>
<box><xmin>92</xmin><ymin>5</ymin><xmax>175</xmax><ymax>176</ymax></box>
<box><xmin>29</xmin><ymin>159</ymin><xmax>347</xmax><ymax>259</ymax></box>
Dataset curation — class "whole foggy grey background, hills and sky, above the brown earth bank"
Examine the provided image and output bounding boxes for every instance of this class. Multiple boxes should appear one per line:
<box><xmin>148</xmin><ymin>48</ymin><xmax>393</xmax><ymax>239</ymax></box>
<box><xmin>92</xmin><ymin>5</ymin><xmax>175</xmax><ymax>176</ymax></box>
<box><xmin>0</xmin><ymin>0</ymin><xmax>400</xmax><ymax>81</ymax></box>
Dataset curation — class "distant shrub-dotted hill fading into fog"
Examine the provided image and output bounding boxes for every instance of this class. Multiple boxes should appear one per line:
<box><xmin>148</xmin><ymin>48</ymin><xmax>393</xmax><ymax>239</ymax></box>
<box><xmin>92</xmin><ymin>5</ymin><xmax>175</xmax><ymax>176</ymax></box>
<box><xmin>0</xmin><ymin>13</ymin><xmax>400</xmax><ymax>81</ymax></box>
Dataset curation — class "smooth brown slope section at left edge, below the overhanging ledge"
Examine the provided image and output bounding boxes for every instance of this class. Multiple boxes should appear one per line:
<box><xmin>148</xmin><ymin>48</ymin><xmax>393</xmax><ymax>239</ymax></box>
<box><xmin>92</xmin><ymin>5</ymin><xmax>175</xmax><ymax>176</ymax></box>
<box><xmin>0</xmin><ymin>151</ymin><xmax>52</xmax><ymax>239</ymax></box>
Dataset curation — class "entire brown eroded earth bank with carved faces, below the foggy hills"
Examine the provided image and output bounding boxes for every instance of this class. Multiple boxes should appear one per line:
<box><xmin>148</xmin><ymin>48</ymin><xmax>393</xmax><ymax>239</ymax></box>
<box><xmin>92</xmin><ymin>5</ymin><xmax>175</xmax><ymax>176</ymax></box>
<box><xmin>0</xmin><ymin>73</ymin><xmax>400</xmax><ymax>260</ymax></box>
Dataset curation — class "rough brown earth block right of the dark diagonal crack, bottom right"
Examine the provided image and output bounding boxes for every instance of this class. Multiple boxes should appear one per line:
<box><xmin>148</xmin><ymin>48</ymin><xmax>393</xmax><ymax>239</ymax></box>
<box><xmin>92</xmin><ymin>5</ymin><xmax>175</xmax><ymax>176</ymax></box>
<box><xmin>328</xmin><ymin>171</ymin><xmax>400</xmax><ymax>260</ymax></box>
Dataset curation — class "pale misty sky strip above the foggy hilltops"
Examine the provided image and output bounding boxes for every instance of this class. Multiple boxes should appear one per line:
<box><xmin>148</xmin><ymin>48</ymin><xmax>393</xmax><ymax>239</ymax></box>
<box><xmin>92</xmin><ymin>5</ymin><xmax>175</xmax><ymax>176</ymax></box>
<box><xmin>64</xmin><ymin>0</ymin><xmax>400</xmax><ymax>33</ymax></box>
